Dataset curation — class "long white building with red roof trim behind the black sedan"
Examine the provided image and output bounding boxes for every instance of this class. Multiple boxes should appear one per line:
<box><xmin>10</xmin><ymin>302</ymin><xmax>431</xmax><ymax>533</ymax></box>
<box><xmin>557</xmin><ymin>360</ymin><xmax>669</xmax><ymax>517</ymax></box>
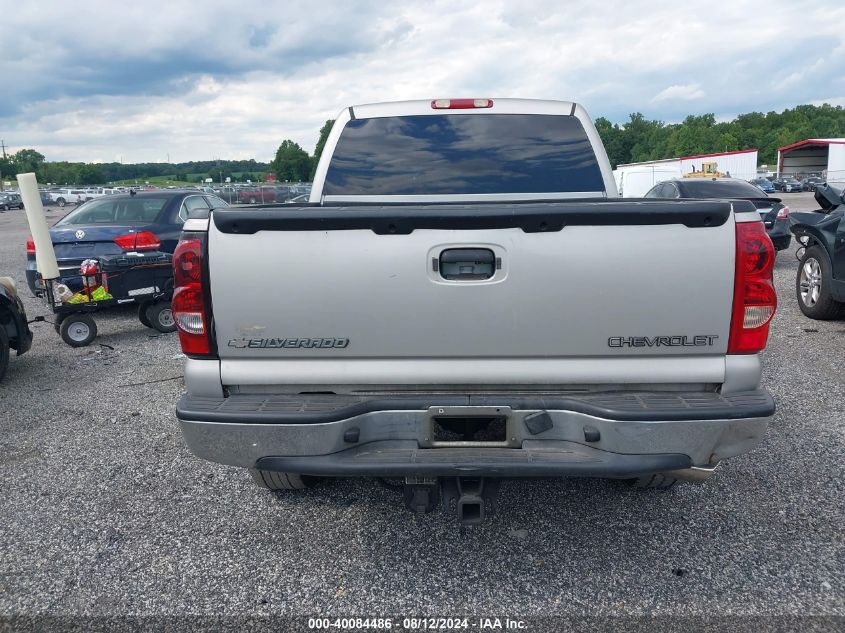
<box><xmin>613</xmin><ymin>149</ymin><xmax>757</xmax><ymax>198</ymax></box>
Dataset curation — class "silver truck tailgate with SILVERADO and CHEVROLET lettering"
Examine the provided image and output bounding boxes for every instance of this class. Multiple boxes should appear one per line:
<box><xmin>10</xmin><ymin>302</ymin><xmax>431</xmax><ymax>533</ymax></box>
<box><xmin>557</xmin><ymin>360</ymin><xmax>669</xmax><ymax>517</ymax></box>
<box><xmin>208</xmin><ymin>200</ymin><xmax>750</xmax><ymax>384</ymax></box>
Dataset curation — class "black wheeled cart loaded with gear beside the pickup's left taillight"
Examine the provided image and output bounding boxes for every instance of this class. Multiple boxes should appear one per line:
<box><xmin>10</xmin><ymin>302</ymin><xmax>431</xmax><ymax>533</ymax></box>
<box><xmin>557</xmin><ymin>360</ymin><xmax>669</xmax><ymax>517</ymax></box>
<box><xmin>42</xmin><ymin>251</ymin><xmax>176</xmax><ymax>347</ymax></box>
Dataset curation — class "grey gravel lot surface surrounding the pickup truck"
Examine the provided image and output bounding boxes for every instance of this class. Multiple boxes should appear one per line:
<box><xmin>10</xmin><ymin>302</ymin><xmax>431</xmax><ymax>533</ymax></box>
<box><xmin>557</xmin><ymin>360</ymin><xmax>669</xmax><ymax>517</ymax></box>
<box><xmin>0</xmin><ymin>194</ymin><xmax>845</xmax><ymax>630</ymax></box>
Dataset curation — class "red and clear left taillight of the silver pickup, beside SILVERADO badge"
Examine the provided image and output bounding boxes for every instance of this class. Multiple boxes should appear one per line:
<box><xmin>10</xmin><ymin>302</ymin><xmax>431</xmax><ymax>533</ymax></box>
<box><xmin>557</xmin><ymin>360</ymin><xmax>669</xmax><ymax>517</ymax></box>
<box><xmin>171</xmin><ymin>233</ymin><xmax>214</xmax><ymax>356</ymax></box>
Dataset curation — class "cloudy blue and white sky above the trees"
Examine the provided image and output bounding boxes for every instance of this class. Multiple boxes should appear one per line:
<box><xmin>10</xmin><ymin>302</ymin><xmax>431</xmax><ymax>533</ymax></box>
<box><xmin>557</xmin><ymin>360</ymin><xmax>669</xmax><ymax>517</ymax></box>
<box><xmin>0</xmin><ymin>0</ymin><xmax>845</xmax><ymax>163</ymax></box>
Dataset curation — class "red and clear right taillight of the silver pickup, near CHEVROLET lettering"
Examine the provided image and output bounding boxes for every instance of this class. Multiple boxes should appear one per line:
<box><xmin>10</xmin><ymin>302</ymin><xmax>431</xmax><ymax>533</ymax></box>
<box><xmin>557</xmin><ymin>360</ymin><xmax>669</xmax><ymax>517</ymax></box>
<box><xmin>728</xmin><ymin>221</ymin><xmax>777</xmax><ymax>354</ymax></box>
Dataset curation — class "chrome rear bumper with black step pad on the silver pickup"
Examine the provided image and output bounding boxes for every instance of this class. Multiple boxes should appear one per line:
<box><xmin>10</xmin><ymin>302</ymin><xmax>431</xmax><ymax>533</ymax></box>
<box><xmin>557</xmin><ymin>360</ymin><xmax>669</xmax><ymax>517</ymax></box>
<box><xmin>177</xmin><ymin>390</ymin><xmax>775</xmax><ymax>477</ymax></box>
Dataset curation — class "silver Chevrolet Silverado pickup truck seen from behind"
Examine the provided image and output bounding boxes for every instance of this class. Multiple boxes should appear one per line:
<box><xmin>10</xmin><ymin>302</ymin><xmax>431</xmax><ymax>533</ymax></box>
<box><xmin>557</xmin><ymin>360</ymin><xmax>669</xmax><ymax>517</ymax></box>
<box><xmin>173</xmin><ymin>99</ymin><xmax>776</xmax><ymax>522</ymax></box>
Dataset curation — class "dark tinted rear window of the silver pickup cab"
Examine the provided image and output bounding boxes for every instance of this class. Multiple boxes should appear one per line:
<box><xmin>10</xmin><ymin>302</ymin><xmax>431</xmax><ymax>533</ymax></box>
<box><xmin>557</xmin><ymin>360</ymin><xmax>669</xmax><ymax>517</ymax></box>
<box><xmin>323</xmin><ymin>114</ymin><xmax>604</xmax><ymax>196</ymax></box>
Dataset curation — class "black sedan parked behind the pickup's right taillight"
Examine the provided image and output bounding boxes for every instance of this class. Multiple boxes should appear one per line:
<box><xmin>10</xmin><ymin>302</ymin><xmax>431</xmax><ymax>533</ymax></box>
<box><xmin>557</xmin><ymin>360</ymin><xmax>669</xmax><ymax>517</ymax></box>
<box><xmin>645</xmin><ymin>178</ymin><xmax>792</xmax><ymax>251</ymax></box>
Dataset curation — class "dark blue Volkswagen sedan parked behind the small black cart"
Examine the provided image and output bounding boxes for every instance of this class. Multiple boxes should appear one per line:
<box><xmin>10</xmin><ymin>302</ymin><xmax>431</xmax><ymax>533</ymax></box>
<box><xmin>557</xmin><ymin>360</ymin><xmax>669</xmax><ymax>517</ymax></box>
<box><xmin>26</xmin><ymin>190</ymin><xmax>229</xmax><ymax>294</ymax></box>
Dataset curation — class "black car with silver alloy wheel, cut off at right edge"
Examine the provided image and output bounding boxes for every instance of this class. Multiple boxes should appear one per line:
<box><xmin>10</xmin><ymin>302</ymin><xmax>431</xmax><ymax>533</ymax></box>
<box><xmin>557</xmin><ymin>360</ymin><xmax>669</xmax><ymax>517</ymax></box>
<box><xmin>790</xmin><ymin>185</ymin><xmax>845</xmax><ymax>320</ymax></box>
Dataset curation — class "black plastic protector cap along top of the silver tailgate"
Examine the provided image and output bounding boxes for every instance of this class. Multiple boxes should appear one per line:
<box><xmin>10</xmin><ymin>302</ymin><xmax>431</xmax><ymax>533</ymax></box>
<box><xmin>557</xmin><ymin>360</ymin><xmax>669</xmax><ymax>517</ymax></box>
<box><xmin>212</xmin><ymin>198</ymin><xmax>744</xmax><ymax>235</ymax></box>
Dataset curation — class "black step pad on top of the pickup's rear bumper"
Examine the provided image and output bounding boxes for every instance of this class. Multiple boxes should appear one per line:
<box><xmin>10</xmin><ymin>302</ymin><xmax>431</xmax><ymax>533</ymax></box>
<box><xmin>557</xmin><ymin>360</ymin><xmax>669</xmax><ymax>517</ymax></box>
<box><xmin>176</xmin><ymin>389</ymin><xmax>775</xmax><ymax>424</ymax></box>
